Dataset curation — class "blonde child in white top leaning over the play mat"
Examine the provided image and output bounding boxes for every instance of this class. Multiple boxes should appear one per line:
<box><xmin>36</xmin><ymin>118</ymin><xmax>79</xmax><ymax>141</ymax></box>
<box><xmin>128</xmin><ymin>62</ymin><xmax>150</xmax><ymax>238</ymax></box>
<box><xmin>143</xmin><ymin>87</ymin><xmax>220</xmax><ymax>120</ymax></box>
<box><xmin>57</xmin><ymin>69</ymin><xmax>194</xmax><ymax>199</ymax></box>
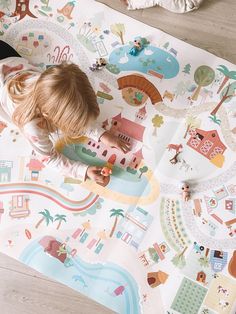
<box><xmin>0</xmin><ymin>41</ymin><xmax>129</xmax><ymax>184</ymax></box>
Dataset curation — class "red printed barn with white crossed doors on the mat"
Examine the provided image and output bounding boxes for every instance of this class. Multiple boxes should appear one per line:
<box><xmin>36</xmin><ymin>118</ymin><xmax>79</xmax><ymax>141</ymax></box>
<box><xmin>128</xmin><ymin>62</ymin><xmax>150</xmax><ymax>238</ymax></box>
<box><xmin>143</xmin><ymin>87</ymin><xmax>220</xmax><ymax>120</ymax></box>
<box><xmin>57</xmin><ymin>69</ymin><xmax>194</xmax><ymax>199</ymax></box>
<box><xmin>187</xmin><ymin>129</ymin><xmax>226</xmax><ymax>160</ymax></box>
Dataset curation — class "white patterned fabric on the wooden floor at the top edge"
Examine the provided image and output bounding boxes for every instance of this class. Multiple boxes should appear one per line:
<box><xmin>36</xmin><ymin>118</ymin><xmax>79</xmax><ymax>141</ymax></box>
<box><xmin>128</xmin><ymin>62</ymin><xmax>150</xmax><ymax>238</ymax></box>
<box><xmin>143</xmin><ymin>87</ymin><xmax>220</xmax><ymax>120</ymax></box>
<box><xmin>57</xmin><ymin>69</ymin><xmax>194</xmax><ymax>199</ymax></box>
<box><xmin>122</xmin><ymin>0</ymin><xmax>203</xmax><ymax>13</ymax></box>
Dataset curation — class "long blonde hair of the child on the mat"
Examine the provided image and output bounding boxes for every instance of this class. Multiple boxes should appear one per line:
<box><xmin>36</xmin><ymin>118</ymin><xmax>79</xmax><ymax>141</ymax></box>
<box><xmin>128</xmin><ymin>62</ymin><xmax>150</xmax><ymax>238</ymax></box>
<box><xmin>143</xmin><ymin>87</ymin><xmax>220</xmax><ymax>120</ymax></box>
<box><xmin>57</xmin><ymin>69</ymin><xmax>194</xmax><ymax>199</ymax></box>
<box><xmin>7</xmin><ymin>62</ymin><xmax>99</xmax><ymax>138</ymax></box>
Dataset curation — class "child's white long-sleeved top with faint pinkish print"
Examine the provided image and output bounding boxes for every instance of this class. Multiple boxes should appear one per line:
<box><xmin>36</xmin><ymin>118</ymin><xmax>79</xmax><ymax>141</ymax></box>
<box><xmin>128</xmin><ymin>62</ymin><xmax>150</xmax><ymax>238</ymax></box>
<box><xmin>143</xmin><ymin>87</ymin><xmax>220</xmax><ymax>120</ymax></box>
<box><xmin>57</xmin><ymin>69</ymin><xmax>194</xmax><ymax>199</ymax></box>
<box><xmin>0</xmin><ymin>57</ymin><xmax>104</xmax><ymax>180</ymax></box>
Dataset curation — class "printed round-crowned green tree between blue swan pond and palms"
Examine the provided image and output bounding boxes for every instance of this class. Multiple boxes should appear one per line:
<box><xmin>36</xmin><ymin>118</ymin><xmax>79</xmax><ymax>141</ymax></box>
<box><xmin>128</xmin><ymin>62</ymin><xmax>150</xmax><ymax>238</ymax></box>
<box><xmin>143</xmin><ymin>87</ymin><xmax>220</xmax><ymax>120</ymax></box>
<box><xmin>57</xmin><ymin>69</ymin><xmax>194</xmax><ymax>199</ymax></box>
<box><xmin>192</xmin><ymin>65</ymin><xmax>215</xmax><ymax>100</ymax></box>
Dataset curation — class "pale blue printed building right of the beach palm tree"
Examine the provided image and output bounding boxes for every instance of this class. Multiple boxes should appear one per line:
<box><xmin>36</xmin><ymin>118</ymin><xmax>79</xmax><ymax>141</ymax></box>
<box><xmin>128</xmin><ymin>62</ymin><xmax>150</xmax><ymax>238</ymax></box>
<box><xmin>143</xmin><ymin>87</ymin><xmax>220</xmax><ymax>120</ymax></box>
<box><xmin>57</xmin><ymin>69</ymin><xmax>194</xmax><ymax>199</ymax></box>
<box><xmin>116</xmin><ymin>207</ymin><xmax>153</xmax><ymax>249</ymax></box>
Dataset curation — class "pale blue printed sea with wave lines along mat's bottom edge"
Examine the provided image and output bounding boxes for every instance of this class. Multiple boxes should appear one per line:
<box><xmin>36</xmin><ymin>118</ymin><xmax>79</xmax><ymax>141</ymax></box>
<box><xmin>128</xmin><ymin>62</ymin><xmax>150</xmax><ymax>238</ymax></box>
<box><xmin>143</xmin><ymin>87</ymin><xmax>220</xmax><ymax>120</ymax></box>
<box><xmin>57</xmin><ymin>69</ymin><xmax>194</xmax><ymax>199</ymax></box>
<box><xmin>20</xmin><ymin>240</ymin><xmax>141</xmax><ymax>314</ymax></box>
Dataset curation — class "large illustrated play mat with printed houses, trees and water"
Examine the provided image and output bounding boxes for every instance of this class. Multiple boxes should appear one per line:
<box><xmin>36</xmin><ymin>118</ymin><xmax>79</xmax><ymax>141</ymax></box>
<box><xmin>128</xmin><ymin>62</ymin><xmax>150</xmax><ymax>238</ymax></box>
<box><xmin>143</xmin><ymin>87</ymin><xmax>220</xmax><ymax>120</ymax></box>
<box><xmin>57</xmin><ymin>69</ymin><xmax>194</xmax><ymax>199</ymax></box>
<box><xmin>0</xmin><ymin>0</ymin><xmax>236</xmax><ymax>314</ymax></box>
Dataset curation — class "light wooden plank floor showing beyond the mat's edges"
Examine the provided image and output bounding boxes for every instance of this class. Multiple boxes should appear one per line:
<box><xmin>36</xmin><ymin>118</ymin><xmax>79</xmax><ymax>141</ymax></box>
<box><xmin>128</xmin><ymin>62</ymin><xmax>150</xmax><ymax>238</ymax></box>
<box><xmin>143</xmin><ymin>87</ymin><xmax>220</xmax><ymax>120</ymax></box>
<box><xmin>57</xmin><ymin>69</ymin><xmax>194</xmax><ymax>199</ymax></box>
<box><xmin>0</xmin><ymin>0</ymin><xmax>236</xmax><ymax>314</ymax></box>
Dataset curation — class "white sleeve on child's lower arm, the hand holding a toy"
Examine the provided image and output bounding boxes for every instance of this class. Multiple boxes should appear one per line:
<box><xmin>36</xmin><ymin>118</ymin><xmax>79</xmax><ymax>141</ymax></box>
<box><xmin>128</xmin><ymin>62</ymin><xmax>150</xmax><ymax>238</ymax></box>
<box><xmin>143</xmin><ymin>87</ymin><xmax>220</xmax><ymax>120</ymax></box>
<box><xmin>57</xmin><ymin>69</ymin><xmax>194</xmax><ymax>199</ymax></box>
<box><xmin>23</xmin><ymin>121</ymin><xmax>88</xmax><ymax>181</ymax></box>
